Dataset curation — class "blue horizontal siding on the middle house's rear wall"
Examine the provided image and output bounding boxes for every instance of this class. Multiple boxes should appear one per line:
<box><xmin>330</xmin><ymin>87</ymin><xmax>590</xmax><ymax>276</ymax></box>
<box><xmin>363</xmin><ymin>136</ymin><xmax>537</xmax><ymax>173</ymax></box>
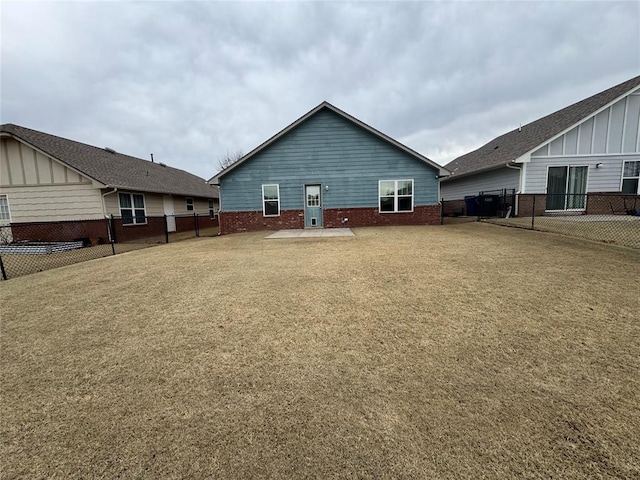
<box><xmin>220</xmin><ymin>110</ymin><xmax>439</xmax><ymax>212</ymax></box>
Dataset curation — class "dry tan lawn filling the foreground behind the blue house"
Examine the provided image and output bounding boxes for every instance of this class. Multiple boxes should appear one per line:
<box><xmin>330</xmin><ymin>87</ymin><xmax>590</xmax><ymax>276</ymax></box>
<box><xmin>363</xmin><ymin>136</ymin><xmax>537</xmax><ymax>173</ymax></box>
<box><xmin>0</xmin><ymin>223</ymin><xmax>640</xmax><ymax>479</ymax></box>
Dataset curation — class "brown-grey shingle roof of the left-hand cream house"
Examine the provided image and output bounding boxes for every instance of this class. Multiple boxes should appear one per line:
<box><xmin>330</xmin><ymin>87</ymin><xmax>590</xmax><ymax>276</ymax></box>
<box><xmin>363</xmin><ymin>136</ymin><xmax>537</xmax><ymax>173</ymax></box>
<box><xmin>0</xmin><ymin>123</ymin><xmax>219</xmax><ymax>198</ymax></box>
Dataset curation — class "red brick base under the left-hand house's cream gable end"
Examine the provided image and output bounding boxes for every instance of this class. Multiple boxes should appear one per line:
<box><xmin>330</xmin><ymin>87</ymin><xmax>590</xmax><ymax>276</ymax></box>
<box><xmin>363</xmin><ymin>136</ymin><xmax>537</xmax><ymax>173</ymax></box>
<box><xmin>11</xmin><ymin>220</ymin><xmax>109</xmax><ymax>245</ymax></box>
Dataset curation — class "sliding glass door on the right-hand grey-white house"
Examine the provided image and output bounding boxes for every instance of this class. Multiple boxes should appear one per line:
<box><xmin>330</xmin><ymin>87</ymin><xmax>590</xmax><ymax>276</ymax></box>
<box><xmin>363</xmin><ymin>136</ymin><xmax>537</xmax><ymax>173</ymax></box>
<box><xmin>547</xmin><ymin>166</ymin><xmax>588</xmax><ymax>210</ymax></box>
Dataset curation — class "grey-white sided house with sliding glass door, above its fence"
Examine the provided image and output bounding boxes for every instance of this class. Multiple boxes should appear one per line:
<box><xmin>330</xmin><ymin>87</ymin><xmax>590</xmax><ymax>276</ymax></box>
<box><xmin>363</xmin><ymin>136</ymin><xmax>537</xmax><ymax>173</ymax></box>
<box><xmin>441</xmin><ymin>76</ymin><xmax>640</xmax><ymax>212</ymax></box>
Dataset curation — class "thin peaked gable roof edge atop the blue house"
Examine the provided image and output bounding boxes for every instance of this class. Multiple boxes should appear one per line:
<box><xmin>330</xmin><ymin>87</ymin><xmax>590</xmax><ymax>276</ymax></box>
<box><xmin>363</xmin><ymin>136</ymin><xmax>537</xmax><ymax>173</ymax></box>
<box><xmin>209</xmin><ymin>101</ymin><xmax>449</xmax><ymax>185</ymax></box>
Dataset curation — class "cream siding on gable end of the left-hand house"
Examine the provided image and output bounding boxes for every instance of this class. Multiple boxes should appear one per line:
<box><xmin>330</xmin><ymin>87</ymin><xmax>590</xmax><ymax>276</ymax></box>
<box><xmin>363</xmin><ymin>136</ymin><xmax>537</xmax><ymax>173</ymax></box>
<box><xmin>0</xmin><ymin>138</ymin><xmax>103</xmax><ymax>223</ymax></box>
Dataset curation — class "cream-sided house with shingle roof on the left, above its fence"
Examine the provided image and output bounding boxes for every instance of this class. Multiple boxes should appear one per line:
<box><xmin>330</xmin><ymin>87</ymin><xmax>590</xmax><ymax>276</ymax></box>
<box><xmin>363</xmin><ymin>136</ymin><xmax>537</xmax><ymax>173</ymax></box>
<box><xmin>0</xmin><ymin>124</ymin><xmax>219</xmax><ymax>242</ymax></box>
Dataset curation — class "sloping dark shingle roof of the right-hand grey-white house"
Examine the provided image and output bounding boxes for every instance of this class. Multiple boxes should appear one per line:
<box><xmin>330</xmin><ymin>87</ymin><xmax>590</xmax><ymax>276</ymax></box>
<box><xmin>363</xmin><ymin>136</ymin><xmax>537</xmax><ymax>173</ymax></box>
<box><xmin>445</xmin><ymin>76</ymin><xmax>640</xmax><ymax>180</ymax></box>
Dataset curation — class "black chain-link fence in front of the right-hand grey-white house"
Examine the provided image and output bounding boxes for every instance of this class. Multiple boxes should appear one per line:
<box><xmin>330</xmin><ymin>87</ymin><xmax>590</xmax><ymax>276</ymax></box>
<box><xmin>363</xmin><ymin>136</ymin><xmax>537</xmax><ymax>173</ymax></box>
<box><xmin>442</xmin><ymin>190</ymin><xmax>640</xmax><ymax>248</ymax></box>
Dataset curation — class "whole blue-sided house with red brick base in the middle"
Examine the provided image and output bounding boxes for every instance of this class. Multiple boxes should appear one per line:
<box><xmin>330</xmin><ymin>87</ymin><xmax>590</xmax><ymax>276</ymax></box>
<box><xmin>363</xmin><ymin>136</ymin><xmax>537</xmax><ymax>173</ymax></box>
<box><xmin>209</xmin><ymin>102</ymin><xmax>448</xmax><ymax>234</ymax></box>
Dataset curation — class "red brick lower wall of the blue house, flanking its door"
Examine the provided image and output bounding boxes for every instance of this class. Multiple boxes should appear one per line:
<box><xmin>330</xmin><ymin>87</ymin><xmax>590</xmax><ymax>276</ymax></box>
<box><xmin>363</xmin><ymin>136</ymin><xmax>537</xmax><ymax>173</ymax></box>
<box><xmin>220</xmin><ymin>205</ymin><xmax>441</xmax><ymax>235</ymax></box>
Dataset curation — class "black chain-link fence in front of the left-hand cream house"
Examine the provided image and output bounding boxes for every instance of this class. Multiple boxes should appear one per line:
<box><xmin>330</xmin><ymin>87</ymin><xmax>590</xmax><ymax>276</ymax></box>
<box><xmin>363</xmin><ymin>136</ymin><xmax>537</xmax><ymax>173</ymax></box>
<box><xmin>0</xmin><ymin>214</ymin><xmax>218</xmax><ymax>280</ymax></box>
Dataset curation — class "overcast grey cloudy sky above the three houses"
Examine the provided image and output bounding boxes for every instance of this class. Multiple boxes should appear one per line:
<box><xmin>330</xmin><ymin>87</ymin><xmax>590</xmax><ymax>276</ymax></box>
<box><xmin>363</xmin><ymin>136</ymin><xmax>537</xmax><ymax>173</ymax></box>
<box><xmin>0</xmin><ymin>1</ymin><xmax>640</xmax><ymax>178</ymax></box>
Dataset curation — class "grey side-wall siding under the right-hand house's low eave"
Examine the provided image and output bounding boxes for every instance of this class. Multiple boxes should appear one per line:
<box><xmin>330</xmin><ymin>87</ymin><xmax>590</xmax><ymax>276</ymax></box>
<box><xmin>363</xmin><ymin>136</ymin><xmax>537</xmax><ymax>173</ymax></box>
<box><xmin>440</xmin><ymin>167</ymin><xmax>520</xmax><ymax>200</ymax></box>
